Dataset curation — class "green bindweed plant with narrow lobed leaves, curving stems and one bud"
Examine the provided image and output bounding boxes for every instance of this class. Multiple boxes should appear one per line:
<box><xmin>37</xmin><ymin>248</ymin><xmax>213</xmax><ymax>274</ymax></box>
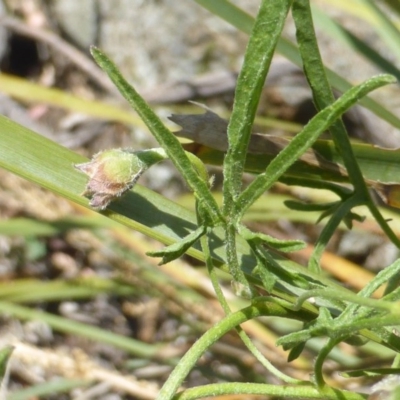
<box><xmin>0</xmin><ymin>0</ymin><xmax>400</xmax><ymax>400</ymax></box>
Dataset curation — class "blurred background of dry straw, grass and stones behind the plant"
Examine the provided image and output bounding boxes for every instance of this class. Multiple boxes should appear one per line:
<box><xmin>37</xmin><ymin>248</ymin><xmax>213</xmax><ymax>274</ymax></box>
<box><xmin>0</xmin><ymin>0</ymin><xmax>400</xmax><ymax>400</ymax></box>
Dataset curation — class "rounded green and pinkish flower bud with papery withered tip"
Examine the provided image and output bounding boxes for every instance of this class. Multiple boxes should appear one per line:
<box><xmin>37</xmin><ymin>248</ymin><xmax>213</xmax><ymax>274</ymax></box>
<box><xmin>75</xmin><ymin>149</ymin><xmax>148</xmax><ymax>210</ymax></box>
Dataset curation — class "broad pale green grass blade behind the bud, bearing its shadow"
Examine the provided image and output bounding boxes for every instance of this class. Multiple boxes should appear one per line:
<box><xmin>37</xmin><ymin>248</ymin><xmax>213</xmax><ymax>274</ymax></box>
<box><xmin>0</xmin><ymin>116</ymin><xmax>201</xmax><ymax>258</ymax></box>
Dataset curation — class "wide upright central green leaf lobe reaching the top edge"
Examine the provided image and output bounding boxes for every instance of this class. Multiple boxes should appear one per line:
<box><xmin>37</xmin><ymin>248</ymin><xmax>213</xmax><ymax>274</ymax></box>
<box><xmin>224</xmin><ymin>0</ymin><xmax>291</xmax><ymax>215</ymax></box>
